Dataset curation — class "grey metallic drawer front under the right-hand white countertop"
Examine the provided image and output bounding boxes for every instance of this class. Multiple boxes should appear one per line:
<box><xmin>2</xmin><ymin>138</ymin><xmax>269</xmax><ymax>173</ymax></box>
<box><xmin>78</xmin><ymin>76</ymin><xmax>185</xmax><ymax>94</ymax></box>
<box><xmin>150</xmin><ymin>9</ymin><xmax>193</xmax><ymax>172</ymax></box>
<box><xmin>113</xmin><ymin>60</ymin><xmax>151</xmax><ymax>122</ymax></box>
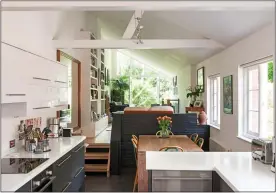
<box><xmin>151</xmin><ymin>171</ymin><xmax>212</xmax><ymax>192</ymax></box>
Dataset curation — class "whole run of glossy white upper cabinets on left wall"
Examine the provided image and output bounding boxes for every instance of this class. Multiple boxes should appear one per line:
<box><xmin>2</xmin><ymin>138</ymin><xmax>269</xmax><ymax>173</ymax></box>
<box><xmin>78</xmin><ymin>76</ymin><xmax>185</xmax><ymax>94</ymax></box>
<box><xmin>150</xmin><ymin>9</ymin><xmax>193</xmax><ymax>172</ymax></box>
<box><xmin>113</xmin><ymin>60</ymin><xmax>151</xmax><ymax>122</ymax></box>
<box><xmin>1</xmin><ymin>43</ymin><xmax>68</xmax><ymax>111</ymax></box>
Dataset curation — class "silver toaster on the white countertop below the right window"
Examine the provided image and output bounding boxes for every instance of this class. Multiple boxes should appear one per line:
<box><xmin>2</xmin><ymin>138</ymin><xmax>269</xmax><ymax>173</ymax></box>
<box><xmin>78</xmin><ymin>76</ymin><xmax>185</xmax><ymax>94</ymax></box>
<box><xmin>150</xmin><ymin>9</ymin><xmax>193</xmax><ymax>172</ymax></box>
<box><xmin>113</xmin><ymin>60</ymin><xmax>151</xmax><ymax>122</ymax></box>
<box><xmin>251</xmin><ymin>138</ymin><xmax>273</xmax><ymax>164</ymax></box>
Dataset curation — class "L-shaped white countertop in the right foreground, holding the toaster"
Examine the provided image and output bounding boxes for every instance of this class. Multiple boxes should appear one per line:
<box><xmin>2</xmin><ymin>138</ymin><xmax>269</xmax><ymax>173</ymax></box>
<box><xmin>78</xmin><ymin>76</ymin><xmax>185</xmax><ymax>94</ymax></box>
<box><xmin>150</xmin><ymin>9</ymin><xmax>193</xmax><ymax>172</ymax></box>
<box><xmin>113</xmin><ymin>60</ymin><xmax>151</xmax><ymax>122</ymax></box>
<box><xmin>146</xmin><ymin>151</ymin><xmax>275</xmax><ymax>192</ymax></box>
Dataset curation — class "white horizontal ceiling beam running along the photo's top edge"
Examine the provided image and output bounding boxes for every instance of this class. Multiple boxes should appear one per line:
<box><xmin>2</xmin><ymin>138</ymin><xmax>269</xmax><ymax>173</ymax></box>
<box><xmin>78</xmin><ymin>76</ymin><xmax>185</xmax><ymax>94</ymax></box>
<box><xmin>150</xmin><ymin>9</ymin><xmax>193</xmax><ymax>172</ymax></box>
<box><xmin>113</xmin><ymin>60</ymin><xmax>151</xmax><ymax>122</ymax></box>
<box><xmin>2</xmin><ymin>0</ymin><xmax>275</xmax><ymax>11</ymax></box>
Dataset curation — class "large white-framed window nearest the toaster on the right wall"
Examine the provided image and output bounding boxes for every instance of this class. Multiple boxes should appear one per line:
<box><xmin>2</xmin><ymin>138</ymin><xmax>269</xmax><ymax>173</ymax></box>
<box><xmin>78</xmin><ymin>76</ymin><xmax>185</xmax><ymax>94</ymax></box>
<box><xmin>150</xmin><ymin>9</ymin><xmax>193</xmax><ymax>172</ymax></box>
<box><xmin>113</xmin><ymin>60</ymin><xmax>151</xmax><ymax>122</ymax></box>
<box><xmin>242</xmin><ymin>59</ymin><xmax>274</xmax><ymax>139</ymax></box>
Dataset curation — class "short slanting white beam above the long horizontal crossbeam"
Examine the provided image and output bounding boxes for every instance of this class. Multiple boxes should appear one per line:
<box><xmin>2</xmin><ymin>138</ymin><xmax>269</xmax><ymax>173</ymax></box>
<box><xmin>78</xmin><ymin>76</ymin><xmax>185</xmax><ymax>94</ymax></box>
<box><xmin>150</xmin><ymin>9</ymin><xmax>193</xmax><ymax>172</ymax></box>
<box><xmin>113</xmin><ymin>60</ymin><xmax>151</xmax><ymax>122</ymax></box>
<box><xmin>123</xmin><ymin>10</ymin><xmax>144</xmax><ymax>39</ymax></box>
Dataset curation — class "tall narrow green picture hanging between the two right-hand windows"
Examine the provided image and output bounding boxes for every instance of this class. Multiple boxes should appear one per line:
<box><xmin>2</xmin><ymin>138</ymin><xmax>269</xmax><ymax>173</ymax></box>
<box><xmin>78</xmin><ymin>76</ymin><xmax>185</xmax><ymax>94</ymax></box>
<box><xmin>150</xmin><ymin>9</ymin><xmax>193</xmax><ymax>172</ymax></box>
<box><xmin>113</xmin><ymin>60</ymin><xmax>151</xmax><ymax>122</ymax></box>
<box><xmin>223</xmin><ymin>75</ymin><xmax>233</xmax><ymax>114</ymax></box>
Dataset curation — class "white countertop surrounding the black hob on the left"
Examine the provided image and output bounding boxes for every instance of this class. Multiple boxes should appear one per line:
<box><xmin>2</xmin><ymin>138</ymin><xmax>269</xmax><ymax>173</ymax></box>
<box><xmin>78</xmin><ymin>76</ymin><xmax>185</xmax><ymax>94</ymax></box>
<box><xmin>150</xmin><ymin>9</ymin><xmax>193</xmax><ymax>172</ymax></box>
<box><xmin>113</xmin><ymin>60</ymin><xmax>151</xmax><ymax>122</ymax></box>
<box><xmin>1</xmin><ymin>136</ymin><xmax>86</xmax><ymax>192</ymax></box>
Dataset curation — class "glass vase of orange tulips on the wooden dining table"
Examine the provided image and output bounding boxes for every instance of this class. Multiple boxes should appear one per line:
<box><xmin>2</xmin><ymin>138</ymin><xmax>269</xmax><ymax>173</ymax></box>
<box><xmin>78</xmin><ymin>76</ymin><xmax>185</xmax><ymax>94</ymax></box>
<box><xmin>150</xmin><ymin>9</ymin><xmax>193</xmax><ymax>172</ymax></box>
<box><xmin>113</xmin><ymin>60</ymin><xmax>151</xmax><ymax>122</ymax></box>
<box><xmin>156</xmin><ymin>116</ymin><xmax>173</xmax><ymax>138</ymax></box>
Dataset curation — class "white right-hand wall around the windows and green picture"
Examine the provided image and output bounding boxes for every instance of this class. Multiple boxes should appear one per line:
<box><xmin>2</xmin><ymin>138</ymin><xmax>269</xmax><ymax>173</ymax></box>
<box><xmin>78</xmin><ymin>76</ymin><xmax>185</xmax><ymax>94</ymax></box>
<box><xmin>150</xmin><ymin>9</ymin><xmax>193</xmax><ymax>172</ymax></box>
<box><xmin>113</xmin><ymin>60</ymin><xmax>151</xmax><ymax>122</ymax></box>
<box><xmin>193</xmin><ymin>25</ymin><xmax>275</xmax><ymax>151</ymax></box>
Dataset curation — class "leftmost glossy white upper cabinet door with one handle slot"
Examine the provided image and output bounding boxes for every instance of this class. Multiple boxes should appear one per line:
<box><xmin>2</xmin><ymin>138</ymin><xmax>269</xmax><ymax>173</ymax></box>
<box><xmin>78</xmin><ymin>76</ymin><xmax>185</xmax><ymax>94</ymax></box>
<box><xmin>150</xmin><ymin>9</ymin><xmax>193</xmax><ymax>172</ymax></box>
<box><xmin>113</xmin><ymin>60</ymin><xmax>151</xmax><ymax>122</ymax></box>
<box><xmin>1</xmin><ymin>43</ymin><xmax>30</xmax><ymax>103</ymax></box>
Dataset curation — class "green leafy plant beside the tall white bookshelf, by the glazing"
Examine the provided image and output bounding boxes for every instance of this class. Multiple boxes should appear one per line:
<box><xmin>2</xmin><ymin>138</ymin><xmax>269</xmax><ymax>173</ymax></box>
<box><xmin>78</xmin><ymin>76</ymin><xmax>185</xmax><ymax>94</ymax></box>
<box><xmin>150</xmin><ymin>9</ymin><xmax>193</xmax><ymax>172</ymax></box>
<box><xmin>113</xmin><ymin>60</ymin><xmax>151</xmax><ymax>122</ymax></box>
<box><xmin>111</xmin><ymin>76</ymin><xmax>129</xmax><ymax>104</ymax></box>
